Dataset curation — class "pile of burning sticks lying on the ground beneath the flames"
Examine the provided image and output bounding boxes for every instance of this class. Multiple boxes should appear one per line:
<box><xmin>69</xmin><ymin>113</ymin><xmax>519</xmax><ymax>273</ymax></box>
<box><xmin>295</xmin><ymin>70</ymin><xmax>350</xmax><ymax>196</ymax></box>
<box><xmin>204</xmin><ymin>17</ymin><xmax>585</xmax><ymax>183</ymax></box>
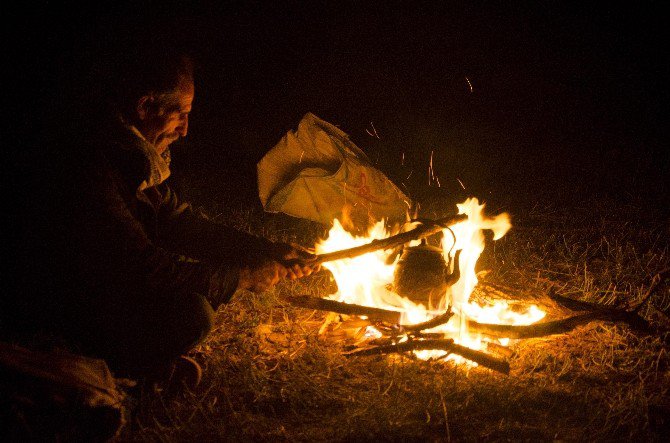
<box><xmin>289</xmin><ymin>276</ymin><xmax>660</xmax><ymax>375</ymax></box>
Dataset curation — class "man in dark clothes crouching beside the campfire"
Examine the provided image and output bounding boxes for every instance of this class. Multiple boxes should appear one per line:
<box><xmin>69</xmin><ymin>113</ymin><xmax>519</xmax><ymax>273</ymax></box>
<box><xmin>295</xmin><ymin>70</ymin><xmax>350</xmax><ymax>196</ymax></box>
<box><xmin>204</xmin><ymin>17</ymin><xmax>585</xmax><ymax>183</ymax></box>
<box><xmin>3</xmin><ymin>42</ymin><xmax>313</xmax><ymax>377</ymax></box>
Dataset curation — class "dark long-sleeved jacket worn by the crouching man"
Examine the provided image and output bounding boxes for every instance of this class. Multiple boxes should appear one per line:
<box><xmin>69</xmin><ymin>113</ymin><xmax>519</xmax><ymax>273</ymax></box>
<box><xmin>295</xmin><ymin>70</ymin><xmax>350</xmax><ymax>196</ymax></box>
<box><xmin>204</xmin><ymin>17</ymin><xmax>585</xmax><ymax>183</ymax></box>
<box><xmin>4</xmin><ymin>121</ymin><xmax>274</xmax><ymax>346</ymax></box>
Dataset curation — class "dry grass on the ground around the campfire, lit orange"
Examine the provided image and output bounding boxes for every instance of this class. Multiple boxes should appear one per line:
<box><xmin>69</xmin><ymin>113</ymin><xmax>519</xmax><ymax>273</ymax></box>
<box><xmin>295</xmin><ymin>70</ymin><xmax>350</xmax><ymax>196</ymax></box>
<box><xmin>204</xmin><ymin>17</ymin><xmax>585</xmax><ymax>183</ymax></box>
<box><xmin>120</xmin><ymin>195</ymin><xmax>670</xmax><ymax>441</ymax></box>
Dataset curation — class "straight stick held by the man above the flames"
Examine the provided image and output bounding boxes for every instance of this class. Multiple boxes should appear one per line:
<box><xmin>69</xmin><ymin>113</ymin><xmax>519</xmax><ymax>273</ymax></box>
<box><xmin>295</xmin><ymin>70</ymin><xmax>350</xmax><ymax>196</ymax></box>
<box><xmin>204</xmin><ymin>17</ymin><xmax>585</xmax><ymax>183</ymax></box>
<box><xmin>314</xmin><ymin>214</ymin><xmax>468</xmax><ymax>264</ymax></box>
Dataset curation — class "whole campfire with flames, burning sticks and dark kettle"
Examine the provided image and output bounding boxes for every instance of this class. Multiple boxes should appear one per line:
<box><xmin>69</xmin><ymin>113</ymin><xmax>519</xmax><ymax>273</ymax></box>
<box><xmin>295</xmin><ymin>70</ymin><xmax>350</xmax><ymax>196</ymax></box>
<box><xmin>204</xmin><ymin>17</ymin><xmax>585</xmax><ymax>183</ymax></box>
<box><xmin>291</xmin><ymin>198</ymin><xmax>652</xmax><ymax>374</ymax></box>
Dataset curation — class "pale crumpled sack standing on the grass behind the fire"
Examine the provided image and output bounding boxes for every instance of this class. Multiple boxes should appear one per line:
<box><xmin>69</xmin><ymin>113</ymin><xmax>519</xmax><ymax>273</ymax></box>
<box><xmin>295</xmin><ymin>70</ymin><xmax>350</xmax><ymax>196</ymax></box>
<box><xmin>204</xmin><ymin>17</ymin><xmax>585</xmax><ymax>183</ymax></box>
<box><xmin>257</xmin><ymin>113</ymin><xmax>411</xmax><ymax>231</ymax></box>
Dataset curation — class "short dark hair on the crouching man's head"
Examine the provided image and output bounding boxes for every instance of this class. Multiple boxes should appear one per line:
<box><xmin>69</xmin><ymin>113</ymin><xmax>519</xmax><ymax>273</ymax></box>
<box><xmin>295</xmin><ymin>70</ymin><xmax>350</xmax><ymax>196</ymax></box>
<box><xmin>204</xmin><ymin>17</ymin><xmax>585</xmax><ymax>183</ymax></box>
<box><xmin>110</xmin><ymin>42</ymin><xmax>194</xmax><ymax>117</ymax></box>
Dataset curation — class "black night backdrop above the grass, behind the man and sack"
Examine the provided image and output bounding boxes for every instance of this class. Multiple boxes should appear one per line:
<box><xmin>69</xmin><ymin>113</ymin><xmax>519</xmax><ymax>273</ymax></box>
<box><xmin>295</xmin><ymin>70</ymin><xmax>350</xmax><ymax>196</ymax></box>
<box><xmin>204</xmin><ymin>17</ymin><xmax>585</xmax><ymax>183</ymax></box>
<box><xmin>6</xmin><ymin>1</ymin><xmax>668</xmax><ymax>215</ymax></box>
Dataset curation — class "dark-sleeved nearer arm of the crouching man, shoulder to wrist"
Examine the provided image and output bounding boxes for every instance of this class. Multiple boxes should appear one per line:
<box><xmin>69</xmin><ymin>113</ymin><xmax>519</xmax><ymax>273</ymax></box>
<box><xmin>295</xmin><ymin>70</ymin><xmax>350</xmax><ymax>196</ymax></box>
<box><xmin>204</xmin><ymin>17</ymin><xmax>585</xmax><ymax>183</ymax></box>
<box><xmin>79</xmin><ymin>174</ymin><xmax>240</xmax><ymax>308</ymax></box>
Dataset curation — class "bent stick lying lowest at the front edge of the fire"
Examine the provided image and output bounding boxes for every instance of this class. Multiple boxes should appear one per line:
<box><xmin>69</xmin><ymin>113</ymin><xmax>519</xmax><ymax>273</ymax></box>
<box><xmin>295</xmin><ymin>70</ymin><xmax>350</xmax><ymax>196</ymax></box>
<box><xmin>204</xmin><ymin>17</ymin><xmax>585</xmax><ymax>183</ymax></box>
<box><xmin>343</xmin><ymin>339</ymin><xmax>510</xmax><ymax>375</ymax></box>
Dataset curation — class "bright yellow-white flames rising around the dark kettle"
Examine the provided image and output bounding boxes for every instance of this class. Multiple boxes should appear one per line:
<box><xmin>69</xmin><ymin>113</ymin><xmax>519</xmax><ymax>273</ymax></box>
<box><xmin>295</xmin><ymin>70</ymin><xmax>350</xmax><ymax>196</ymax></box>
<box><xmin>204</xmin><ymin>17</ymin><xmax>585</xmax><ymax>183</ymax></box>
<box><xmin>316</xmin><ymin>198</ymin><xmax>545</xmax><ymax>359</ymax></box>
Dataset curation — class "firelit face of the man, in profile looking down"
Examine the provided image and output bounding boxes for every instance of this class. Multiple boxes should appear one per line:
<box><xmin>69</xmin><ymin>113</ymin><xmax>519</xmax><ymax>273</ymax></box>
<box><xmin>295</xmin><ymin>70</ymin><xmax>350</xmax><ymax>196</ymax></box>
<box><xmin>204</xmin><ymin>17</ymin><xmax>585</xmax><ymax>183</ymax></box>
<box><xmin>138</xmin><ymin>79</ymin><xmax>195</xmax><ymax>154</ymax></box>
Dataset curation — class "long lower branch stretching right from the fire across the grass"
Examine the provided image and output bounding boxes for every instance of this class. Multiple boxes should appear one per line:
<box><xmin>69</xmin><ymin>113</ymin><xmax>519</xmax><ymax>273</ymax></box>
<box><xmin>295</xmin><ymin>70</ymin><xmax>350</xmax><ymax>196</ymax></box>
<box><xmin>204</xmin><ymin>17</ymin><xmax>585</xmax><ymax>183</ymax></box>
<box><xmin>468</xmin><ymin>310</ymin><xmax>646</xmax><ymax>339</ymax></box>
